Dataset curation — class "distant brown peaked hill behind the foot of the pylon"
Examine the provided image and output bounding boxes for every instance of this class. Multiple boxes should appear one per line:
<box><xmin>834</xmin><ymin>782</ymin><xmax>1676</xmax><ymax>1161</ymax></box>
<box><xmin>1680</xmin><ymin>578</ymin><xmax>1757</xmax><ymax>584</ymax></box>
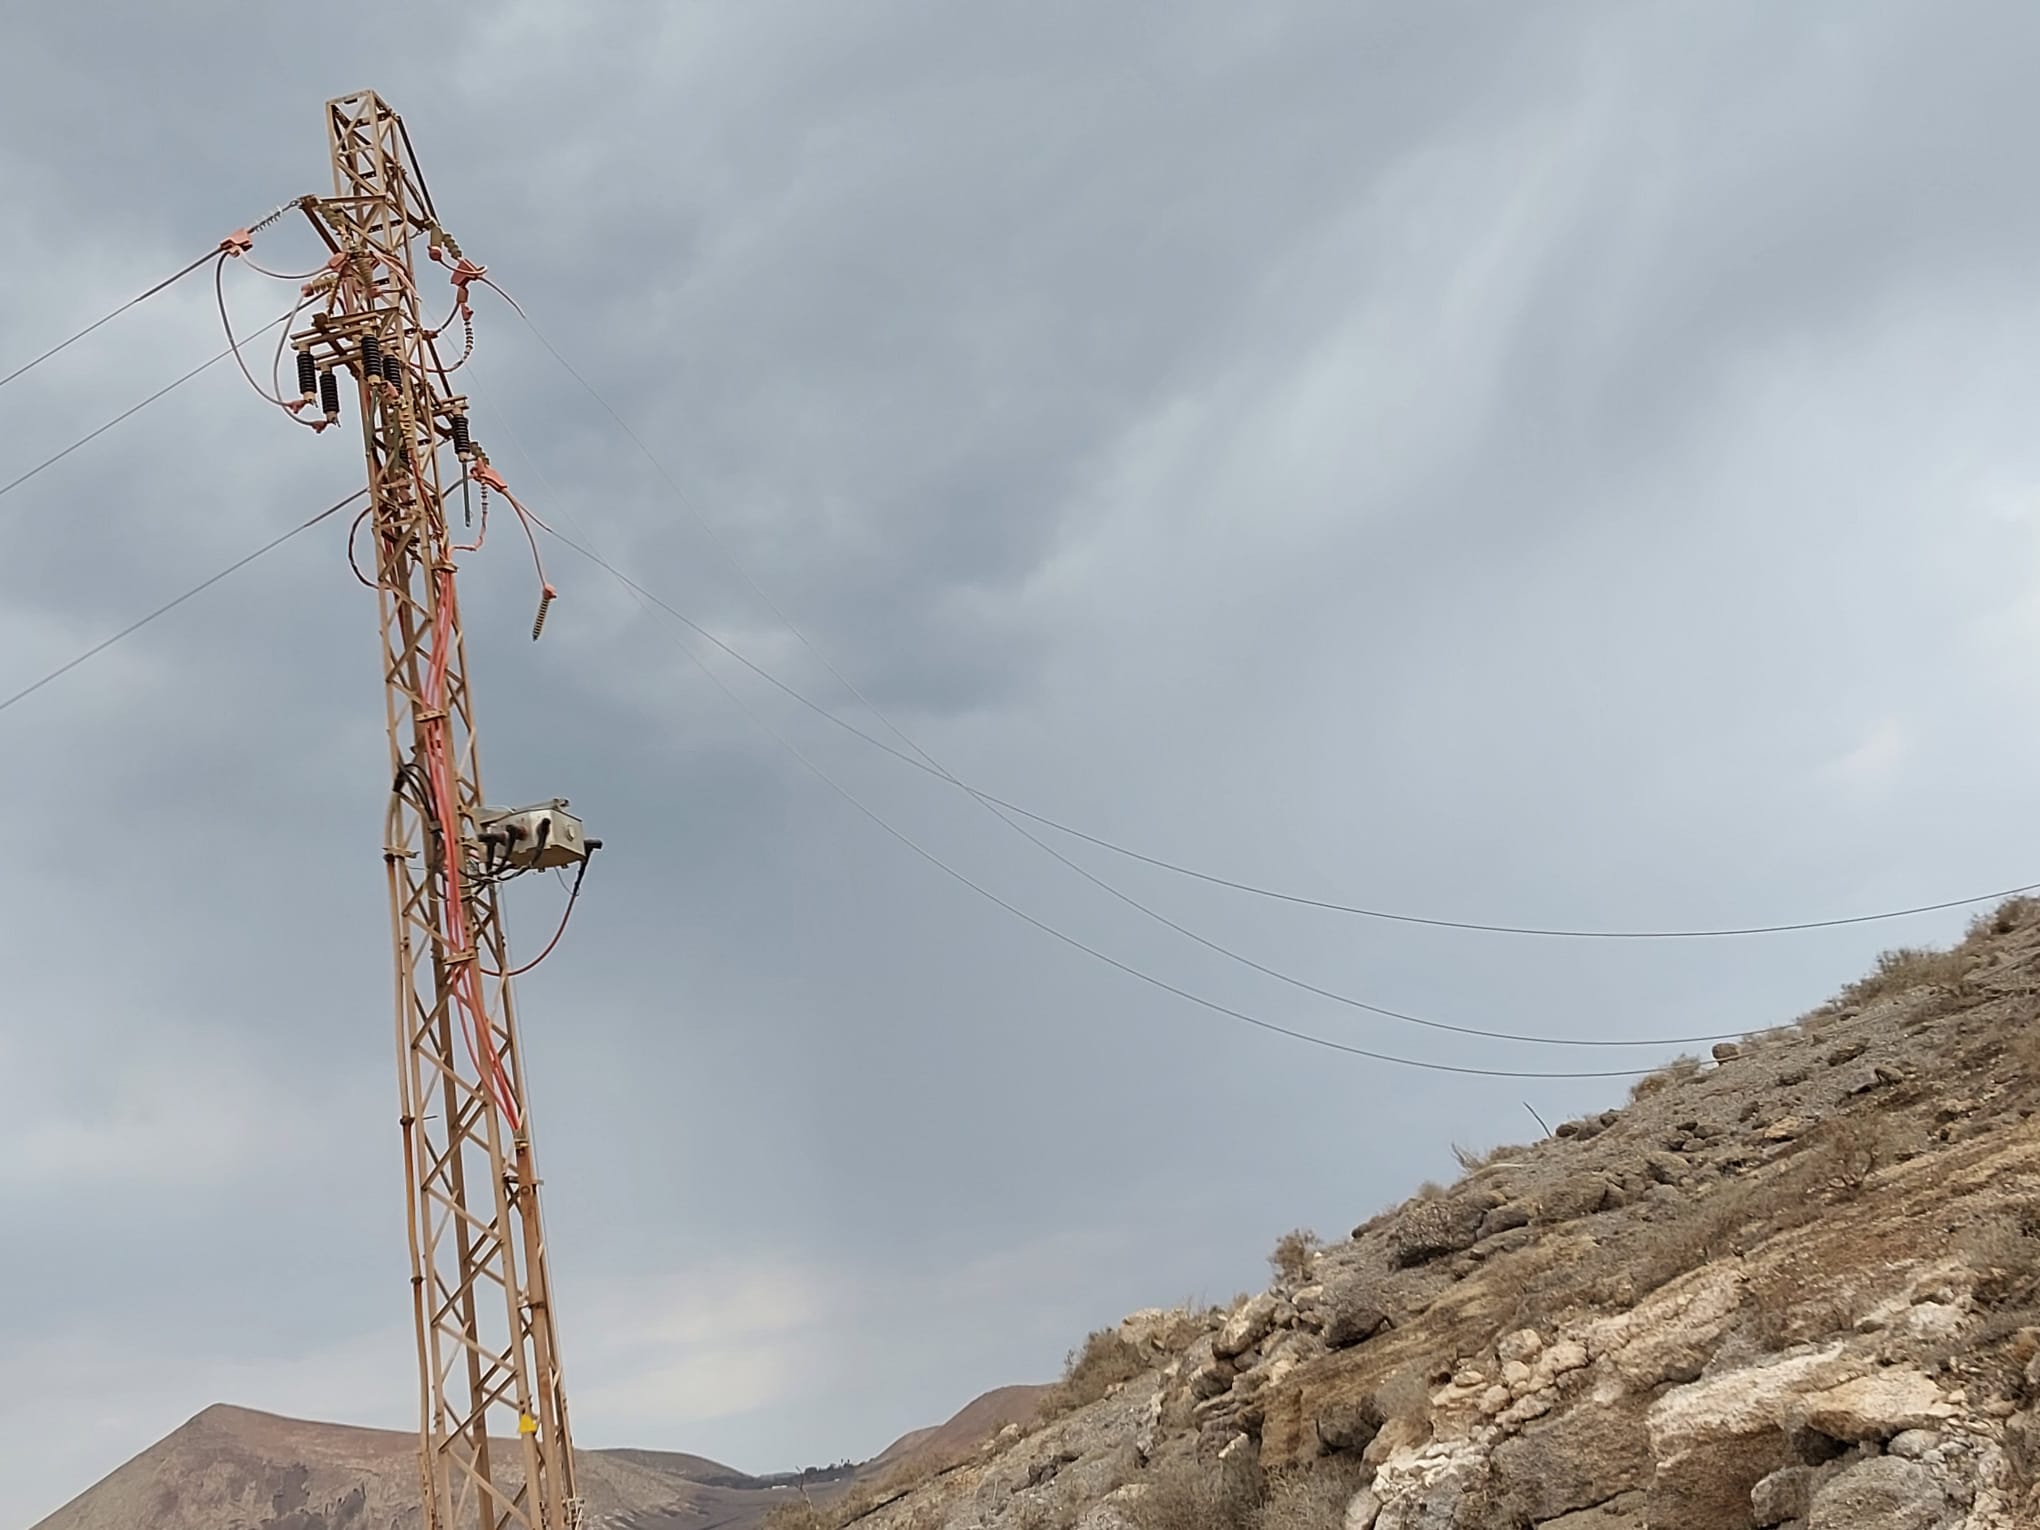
<box><xmin>35</xmin><ymin>1406</ymin><xmax>795</xmax><ymax>1530</ymax></box>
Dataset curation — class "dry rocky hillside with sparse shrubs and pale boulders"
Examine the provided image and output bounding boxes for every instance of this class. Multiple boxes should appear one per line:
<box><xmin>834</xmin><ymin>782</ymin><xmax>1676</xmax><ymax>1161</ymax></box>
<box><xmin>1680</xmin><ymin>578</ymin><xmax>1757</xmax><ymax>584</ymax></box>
<box><xmin>773</xmin><ymin>900</ymin><xmax>2040</xmax><ymax>1530</ymax></box>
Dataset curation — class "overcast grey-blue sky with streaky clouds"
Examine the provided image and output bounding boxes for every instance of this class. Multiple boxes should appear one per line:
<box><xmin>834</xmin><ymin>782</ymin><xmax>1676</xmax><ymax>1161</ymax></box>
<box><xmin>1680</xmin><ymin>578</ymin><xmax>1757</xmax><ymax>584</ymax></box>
<box><xmin>0</xmin><ymin>0</ymin><xmax>2040</xmax><ymax>1526</ymax></box>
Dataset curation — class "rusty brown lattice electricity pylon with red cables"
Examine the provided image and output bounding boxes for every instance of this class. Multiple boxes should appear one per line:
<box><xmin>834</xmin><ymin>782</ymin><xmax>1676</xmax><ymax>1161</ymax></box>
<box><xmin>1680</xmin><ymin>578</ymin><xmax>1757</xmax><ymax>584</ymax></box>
<box><xmin>292</xmin><ymin>92</ymin><xmax>585</xmax><ymax>1530</ymax></box>
